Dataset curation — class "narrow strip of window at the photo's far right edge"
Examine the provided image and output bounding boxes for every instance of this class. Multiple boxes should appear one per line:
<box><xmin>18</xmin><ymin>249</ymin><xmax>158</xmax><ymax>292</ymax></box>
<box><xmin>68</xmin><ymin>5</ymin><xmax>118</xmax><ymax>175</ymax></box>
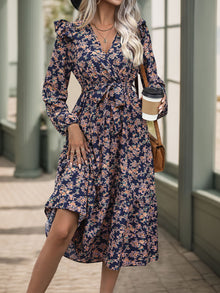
<box><xmin>215</xmin><ymin>0</ymin><xmax>220</xmax><ymax>172</ymax></box>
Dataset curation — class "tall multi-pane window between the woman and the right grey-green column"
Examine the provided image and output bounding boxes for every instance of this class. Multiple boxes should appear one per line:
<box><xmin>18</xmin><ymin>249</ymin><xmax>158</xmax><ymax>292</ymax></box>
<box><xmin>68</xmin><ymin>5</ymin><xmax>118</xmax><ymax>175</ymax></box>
<box><xmin>151</xmin><ymin>0</ymin><xmax>180</xmax><ymax>165</ymax></box>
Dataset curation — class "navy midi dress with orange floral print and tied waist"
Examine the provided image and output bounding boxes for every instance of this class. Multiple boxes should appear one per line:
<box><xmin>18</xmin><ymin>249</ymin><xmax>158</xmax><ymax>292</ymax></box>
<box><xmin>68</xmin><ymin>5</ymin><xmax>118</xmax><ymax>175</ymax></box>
<box><xmin>42</xmin><ymin>17</ymin><xmax>168</xmax><ymax>270</ymax></box>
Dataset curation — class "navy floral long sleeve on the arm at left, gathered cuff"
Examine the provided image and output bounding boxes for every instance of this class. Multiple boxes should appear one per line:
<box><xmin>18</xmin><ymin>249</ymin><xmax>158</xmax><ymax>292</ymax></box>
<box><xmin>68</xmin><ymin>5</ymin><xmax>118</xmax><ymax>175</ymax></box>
<box><xmin>42</xmin><ymin>21</ymin><xmax>78</xmax><ymax>136</ymax></box>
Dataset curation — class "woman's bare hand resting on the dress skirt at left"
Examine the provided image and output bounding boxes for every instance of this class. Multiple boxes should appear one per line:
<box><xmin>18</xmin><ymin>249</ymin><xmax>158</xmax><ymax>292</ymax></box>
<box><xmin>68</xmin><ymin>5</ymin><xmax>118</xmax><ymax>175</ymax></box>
<box><xmin>67</xmin><ymin>123</ymin><xmax>89</xmax><ymax>169</ymax></box>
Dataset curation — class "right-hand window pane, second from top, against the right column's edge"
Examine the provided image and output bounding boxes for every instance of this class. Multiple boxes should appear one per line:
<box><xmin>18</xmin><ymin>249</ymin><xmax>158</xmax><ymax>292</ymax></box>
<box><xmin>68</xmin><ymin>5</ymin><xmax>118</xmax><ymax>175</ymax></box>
<box><xmin>167</xmin><ymin>27</ymin><xmax>180</xmax><ymax>82</ymax></box>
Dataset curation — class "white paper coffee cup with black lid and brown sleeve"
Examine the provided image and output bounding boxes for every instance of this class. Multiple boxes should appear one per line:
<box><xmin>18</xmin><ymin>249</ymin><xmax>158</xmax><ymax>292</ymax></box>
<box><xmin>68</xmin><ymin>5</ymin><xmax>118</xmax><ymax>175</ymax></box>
<box><xmin>142</xmin><ymin>87</ymin><xmax>164</xmax><ymax>121</ymax></box>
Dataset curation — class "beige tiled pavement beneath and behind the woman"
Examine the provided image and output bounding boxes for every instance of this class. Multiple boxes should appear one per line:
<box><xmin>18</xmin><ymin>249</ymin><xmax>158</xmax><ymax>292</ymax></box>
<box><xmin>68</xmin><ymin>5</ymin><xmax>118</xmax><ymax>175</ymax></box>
<box><xmin>0</xmin><ymin>157</ymin><xmax>220</xmax><ymax>293</ymax></box>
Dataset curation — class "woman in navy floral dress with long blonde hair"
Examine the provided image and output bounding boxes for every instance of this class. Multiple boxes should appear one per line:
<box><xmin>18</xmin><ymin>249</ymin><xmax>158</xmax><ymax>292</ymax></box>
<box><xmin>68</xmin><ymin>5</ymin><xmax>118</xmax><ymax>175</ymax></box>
<box><xmin>27</xmin><ymin>0</ymin><xmax>168</xmax><ymax>293</ymax></box>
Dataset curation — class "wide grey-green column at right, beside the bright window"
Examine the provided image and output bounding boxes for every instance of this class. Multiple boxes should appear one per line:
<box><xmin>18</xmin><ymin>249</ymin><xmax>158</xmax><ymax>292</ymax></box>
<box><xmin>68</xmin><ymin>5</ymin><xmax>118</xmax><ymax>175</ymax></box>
<box><xmin>178</xmin><ymin>0</ymin><xmax>217</xmax><ymax>250</ymax></box>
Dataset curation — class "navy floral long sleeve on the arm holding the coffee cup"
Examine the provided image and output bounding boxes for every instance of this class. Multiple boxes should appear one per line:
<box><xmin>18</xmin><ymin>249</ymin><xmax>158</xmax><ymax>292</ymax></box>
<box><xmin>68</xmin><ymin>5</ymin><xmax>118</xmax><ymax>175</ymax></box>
<box><xmin>139</xmin><ymin>18</ymin><xmax>168</xmax><ymax>120</ymax></box>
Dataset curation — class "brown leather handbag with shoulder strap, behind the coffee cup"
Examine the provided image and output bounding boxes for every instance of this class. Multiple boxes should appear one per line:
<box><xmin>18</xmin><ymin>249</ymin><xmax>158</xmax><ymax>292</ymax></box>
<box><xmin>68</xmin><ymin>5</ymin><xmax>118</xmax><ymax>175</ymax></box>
<box><xmin>135</xmin><ymin>64</ymin><xmax>165</xmax><ymax>172</ymax></box>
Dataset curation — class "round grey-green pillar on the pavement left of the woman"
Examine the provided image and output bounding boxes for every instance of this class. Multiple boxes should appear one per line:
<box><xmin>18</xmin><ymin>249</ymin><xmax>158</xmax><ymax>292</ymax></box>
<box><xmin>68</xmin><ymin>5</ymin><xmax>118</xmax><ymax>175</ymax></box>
<box><xmin>14</xmin><ymin>0</ymin><xmax>43</xmax><ymax>177</ymax></box>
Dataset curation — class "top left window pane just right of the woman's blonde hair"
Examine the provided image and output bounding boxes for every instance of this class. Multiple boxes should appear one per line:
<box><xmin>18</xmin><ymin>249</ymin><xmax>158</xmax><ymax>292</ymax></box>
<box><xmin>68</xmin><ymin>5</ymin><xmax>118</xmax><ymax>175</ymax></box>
<box><xmin>151</xmin><ymin>0</ymin><xmax>165</xmax><ymax>28</ymax></box>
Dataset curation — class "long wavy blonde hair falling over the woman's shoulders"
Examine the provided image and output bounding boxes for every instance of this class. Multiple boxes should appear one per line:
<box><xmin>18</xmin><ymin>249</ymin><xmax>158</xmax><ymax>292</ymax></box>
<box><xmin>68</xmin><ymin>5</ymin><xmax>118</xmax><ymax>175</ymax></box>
<box><xmin>75</xmin><ymin>0</ymin><xmax>143</xmax><ymax>67</ymax></box>
